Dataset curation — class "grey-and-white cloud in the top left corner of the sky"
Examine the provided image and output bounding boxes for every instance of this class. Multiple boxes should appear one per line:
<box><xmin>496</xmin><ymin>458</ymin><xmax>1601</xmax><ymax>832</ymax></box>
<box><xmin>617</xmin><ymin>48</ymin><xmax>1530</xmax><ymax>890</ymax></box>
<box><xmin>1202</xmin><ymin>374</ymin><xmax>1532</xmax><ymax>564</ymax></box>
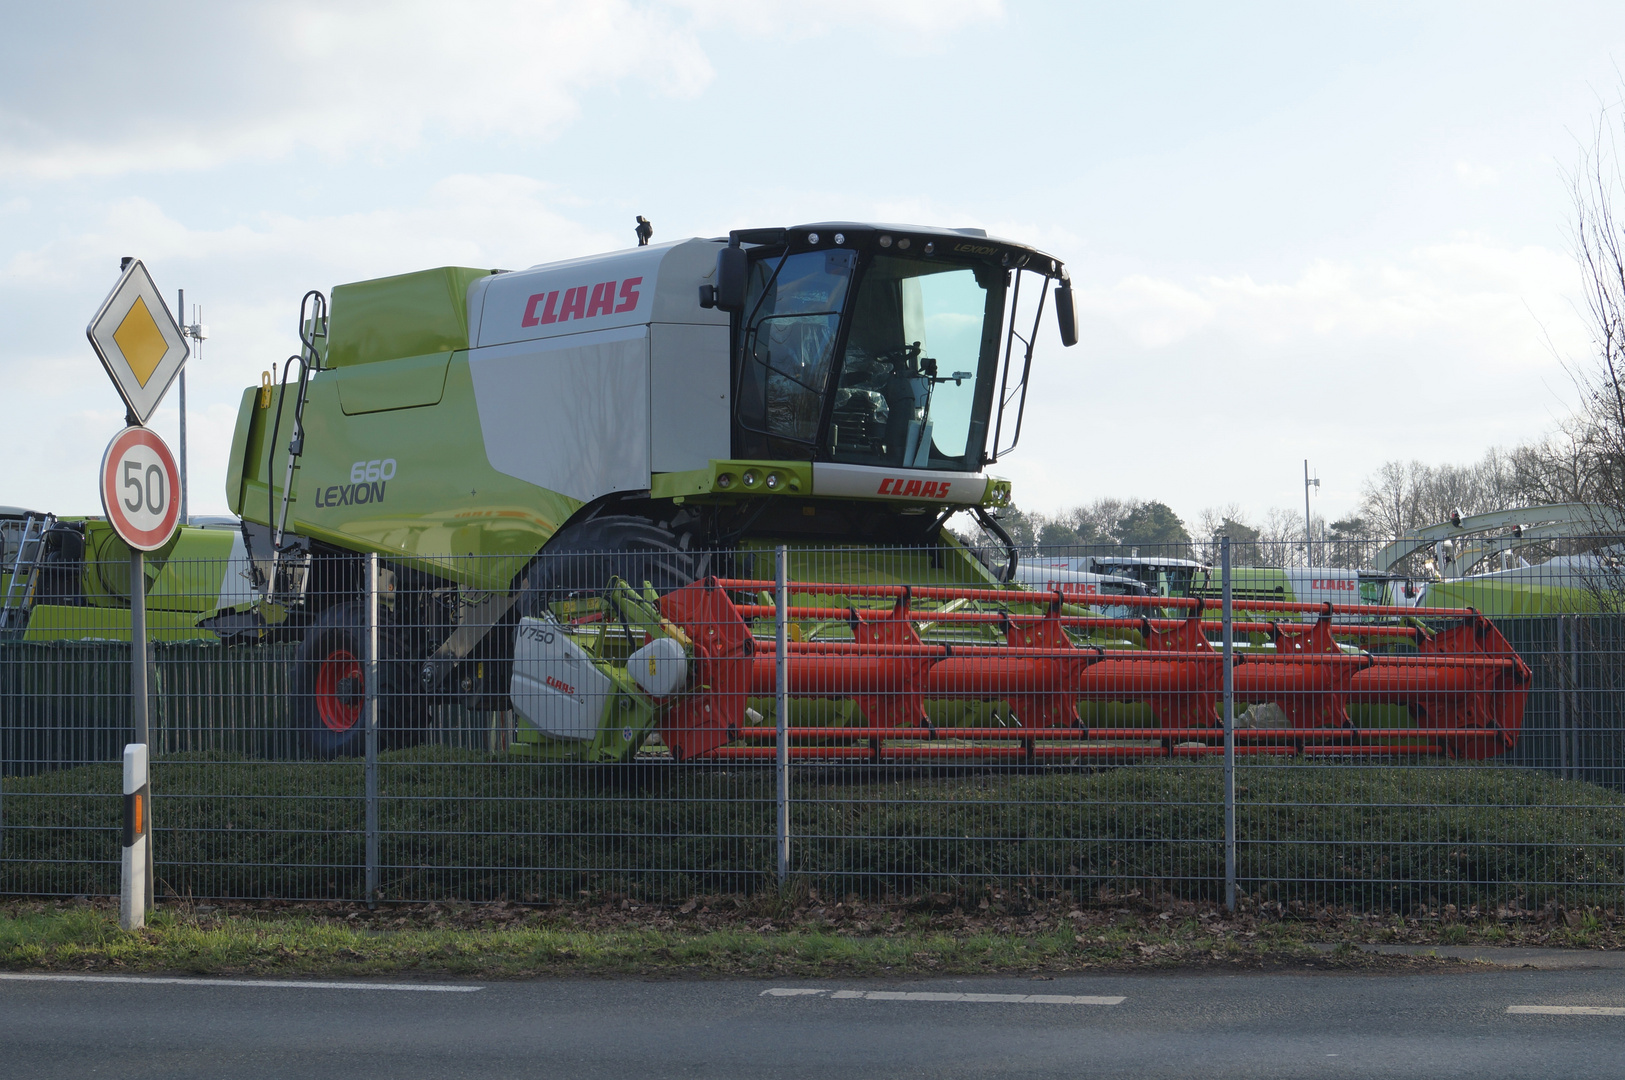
<box><xmin>0</xmin><ymin>0</ymin><xmax>712</xmax><ymax>179</ymax></box>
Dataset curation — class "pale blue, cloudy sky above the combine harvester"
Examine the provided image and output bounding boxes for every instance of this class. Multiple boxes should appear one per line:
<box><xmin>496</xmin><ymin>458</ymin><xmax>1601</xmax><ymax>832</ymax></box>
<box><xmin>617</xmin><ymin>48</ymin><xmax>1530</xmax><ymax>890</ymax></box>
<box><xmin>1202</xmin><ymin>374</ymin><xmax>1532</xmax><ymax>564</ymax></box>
<box><xmin>0</xmin><ymin>0</ymin><xmax>1625</xmax><ymax>525</ymax></box>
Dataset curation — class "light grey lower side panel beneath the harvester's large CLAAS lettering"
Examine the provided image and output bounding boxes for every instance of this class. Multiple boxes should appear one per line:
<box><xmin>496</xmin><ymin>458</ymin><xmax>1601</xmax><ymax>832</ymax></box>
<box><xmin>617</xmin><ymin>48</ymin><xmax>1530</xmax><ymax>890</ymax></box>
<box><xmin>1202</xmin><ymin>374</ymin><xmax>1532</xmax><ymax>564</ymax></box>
<box><xmin>468</xmin><ymin>326</ymin><xmax>650</xmax><ymax>502</ymax></box>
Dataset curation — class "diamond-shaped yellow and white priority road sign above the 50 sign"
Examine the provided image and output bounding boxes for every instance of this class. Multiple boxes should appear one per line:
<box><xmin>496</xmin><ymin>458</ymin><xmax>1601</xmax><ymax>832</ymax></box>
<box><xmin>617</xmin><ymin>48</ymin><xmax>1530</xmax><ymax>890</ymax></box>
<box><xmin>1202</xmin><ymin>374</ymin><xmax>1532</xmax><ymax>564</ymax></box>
<box><xmin>85</xmin><ymin>260</ymin><xmax>190</xmax><ymax>424</ymax></box>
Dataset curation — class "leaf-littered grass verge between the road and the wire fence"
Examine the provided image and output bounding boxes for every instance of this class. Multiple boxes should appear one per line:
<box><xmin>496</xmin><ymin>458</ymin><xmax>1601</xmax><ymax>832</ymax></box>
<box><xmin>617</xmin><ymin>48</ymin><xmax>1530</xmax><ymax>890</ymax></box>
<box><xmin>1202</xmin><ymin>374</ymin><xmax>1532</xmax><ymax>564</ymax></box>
<box><xmin>0</xmin><ymin>893</ymin><xmax>1625</xmax><ymax>979</ymax></box>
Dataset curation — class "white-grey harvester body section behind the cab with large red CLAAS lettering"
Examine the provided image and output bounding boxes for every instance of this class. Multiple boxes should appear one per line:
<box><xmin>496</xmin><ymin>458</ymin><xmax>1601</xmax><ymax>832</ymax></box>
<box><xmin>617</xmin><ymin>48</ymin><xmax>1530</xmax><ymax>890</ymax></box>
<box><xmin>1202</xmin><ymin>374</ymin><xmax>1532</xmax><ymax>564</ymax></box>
<box><xmin>468</xmin><ymin>240</ymin><xmax>730</xmax><ymax>502</ymax></box>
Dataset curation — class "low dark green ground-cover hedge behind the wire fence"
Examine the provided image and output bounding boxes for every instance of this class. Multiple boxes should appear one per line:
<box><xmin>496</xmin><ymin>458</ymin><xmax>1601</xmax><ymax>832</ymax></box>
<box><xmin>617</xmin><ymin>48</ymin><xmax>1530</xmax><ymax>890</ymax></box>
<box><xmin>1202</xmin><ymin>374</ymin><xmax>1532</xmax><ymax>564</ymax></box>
<box><xmin>0</xmin><ymin>747</ymin><xmax>1625</xmax><ymax>913</ymax></box>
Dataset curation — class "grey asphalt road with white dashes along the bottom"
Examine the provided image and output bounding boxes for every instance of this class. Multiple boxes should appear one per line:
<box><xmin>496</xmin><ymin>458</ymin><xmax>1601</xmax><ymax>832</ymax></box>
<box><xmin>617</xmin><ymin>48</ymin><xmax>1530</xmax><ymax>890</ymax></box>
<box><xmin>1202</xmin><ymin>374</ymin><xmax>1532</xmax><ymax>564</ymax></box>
<box><xmin>0</xmin><ymin>968</ymin><xmax>1625</xmax><ymax>1080</ymax></box>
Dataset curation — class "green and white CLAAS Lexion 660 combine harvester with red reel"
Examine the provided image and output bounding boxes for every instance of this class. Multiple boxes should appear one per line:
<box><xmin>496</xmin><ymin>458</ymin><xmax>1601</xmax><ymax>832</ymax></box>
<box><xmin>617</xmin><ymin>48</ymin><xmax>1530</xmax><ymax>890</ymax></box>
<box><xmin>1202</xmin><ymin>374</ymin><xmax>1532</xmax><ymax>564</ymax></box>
<box><xmin>221</xmin><ymin>222</ymin><xmax>1529</xmax><ymax>762</ymax></box>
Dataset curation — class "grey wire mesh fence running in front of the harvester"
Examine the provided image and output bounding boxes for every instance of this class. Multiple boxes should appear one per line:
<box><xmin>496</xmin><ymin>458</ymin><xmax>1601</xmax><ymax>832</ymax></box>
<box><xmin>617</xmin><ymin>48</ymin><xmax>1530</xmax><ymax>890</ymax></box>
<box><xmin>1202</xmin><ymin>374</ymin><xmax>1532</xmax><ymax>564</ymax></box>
<box><xmin>0</xmin><ymin>529</ymin><xmax>1625</xmax><ymax>914</ymax></box>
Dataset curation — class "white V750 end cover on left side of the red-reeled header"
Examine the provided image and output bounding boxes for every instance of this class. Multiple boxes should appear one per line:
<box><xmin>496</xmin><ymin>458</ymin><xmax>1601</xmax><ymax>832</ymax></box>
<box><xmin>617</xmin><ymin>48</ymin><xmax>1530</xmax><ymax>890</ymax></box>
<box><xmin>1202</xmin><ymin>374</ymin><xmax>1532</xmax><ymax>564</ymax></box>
<box><xmin>509</xmin><ymin>617</ymin><xmax>613</xmax><ymax>742</ymax></box>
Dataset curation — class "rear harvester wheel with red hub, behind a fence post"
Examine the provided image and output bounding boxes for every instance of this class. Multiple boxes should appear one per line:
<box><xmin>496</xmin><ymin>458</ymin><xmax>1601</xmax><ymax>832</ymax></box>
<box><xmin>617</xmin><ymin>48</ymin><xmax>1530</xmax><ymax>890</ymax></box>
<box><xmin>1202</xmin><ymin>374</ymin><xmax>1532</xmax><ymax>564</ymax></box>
<box><xmin>289</xmin><ymin>601</ymin><xmax>427</xmax><ymax>758</ymax></box>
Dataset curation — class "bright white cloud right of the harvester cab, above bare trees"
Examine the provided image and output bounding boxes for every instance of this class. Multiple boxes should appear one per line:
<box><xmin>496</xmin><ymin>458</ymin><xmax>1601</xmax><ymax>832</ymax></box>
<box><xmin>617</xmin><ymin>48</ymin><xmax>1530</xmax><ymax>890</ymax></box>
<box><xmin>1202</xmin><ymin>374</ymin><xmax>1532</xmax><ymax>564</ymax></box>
<box><xmin>996</xmin><ymin>235</ymin><xmax>1589</xmax><ymax>521</ymax></box>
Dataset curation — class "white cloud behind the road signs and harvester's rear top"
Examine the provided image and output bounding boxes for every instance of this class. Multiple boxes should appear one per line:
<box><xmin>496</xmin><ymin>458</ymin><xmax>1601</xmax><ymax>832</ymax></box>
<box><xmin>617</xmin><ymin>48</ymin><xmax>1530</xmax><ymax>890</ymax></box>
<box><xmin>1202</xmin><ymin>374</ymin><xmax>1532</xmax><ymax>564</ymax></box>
<box><xmin>0</xmin><ymin>174</ymin><xmax>626</xmax><ymax>513</ymax></box>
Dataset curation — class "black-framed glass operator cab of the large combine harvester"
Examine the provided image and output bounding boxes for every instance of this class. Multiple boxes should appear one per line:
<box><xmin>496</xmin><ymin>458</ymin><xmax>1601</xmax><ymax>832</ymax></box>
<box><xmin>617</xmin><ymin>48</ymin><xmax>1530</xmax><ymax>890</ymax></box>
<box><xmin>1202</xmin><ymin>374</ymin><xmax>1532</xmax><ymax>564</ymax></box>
<box><xmin>718</xmin><ymin>222</ymin><xmax>1076</xmax><ymax>473</ymax></box>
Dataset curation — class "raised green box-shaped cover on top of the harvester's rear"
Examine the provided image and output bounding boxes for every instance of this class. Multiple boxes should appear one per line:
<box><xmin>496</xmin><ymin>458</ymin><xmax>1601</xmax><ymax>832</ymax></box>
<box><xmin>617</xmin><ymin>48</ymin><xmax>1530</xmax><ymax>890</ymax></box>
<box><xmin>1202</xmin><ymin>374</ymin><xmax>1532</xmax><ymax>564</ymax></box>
<box><xmin>323</xmin><ymin>266</ymin><xmax>497</xmax><ymax>367</ymax></box>
